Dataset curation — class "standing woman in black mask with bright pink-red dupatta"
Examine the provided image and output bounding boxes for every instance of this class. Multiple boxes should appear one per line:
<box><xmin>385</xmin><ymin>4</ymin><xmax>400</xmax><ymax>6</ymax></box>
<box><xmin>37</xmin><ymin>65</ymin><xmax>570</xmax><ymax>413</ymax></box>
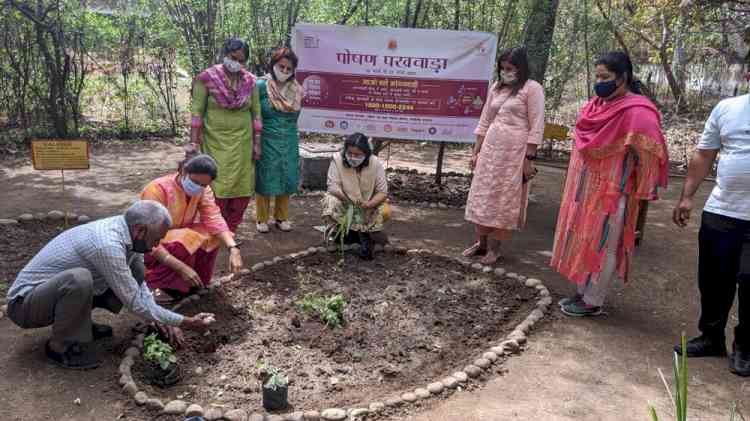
<box><xmin>551</xmin><ymin>52</ymin><xmax>669</xmax><ymax>317</ymax></box>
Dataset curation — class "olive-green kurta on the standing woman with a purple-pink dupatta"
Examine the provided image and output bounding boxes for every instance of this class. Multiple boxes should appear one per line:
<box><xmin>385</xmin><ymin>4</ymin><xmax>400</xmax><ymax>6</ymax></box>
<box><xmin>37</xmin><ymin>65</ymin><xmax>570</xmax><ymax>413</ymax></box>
<box><xmin>192</xmin><ymin>79</ymin><xmax>260</xmax><ymax>199</ymax></box>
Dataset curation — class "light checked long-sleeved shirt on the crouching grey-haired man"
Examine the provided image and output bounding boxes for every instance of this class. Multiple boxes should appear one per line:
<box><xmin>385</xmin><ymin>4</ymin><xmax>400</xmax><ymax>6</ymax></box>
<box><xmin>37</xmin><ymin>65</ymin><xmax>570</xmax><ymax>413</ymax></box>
<box><xmin>8</xmin><ymin>216</ymin><xmax>183</xmax><ymax>326</ymax></box>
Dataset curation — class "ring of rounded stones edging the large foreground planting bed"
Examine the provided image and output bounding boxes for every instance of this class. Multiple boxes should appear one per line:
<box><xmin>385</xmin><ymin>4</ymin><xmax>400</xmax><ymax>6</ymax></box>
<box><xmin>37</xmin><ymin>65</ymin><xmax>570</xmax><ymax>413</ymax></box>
<box><xmin>118</xmin><ymin>245</ymin><xmax>552</xmax><ymax>421</ymax></box>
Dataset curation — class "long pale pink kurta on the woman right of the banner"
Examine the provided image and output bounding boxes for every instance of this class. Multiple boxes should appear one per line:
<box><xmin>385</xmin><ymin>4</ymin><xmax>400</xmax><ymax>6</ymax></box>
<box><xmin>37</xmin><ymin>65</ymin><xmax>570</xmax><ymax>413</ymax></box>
<box><xmin>466</xmin><ymin>80</ymin><xmax>544</xmax><ymax>233</ymax></box>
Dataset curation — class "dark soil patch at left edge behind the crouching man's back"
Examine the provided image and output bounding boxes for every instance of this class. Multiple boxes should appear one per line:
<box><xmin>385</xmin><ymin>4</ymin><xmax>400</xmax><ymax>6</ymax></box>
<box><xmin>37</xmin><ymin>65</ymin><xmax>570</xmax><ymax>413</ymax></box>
<box><xmin>0</xmin><ymin>221</ymin><xmax>63</xmax><ymax>296</ymax></box>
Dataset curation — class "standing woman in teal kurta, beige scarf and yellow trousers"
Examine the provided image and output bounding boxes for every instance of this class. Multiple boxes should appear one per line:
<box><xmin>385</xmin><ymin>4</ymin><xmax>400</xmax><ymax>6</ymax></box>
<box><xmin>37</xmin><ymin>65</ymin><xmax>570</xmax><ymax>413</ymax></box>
<box><xmin>255</xmin><ymin>48</ymin><xmax>302</xmax><ymax>233</ymax></box>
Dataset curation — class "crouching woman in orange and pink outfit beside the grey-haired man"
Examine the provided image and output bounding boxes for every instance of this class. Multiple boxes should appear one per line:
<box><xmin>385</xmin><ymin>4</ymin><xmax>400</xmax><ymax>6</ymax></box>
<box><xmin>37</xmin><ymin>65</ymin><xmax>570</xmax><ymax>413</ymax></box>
<box><xmin>141</xmin><ymin>155</ymin><xmax>242</xmax><ymax>298</ymax></box>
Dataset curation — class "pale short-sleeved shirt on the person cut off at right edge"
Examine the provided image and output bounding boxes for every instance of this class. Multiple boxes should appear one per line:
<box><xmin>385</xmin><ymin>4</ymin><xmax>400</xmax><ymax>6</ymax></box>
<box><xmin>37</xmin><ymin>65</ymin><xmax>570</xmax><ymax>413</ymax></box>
<box><xmin>698</xmin><ymin>95</ymin><xmax>750</xmax><ymax>221</ymax></box>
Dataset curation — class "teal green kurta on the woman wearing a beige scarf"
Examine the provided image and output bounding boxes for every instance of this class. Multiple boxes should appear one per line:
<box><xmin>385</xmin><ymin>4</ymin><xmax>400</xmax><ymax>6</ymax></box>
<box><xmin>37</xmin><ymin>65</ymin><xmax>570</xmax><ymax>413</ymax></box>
<box><xmin>255</xmin><ymin>79</ymin><xmax>300</xmax><ymax>196</ymax></box>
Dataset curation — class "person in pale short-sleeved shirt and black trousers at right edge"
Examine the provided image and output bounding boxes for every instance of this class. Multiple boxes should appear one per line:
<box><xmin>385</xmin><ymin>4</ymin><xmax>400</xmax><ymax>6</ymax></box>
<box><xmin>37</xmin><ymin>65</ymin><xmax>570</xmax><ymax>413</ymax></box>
<box><xmin>673</xmin><ymin>91</ymin><xmax>750</xmax><ymax>376</ymax></box>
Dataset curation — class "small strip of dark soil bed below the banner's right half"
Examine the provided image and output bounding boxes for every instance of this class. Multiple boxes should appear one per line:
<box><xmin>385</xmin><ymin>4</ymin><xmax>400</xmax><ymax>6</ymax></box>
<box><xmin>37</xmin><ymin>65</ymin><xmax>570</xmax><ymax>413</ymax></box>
<box><xmin>388</xmin><ymin>170</ymin><xmax>471</xmax><ymax>206</ymax></box>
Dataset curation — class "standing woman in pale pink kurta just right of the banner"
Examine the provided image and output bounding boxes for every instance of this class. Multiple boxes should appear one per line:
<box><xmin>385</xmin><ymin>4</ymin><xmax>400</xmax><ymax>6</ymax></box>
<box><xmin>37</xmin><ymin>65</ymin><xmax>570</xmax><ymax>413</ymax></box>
<box><xmin>464</xmin><ymin>48</ymin><xmax>544</xmax><ymax>264</ymax></box>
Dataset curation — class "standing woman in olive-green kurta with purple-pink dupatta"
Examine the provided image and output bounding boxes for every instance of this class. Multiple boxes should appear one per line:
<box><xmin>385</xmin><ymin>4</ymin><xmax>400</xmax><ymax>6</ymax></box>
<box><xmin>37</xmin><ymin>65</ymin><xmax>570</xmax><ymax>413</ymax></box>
<box><xmin>189</xmin><ymin>39</ymin><xmax>263</xmax><ymax>232</ymax></box>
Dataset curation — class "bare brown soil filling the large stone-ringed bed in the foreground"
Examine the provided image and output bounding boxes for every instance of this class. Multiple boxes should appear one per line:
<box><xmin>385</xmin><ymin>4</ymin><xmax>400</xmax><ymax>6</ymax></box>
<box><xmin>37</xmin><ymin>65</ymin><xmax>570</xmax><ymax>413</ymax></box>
<box><xmin>133</xmin><ymin>253</ymin><xmax>535</xmax><ymax>411</ymax></box>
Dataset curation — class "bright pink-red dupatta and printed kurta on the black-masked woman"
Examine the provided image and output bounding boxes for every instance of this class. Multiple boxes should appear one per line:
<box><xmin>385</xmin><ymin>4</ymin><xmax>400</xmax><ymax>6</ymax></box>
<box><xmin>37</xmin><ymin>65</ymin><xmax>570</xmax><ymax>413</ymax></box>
<box><xmin>551</xmin><ymin>95</ymin><xmax>669</xmax><ymax>284</ymax></box>
